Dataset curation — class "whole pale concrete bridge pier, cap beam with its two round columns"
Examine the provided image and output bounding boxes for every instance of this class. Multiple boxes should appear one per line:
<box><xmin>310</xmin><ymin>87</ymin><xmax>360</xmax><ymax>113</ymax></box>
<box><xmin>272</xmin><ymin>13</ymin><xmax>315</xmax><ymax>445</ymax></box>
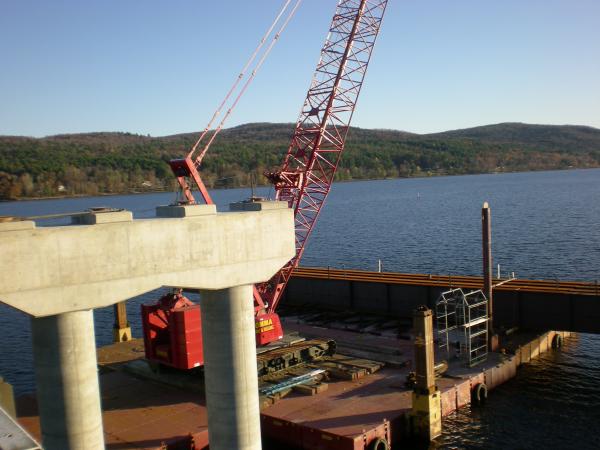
<box><xmin>0</xmin><ymin>202</ymin><xmax>295</xmax><ymax>450</ymax></box>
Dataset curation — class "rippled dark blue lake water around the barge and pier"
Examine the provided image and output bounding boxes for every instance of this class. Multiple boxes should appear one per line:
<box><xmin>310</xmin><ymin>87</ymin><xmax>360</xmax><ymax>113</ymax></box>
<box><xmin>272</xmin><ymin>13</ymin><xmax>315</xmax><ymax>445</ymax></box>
<box><xmin>0</xmin><ymin>169</ymin><xmax>600</xmax><ymax>449</ymax></box>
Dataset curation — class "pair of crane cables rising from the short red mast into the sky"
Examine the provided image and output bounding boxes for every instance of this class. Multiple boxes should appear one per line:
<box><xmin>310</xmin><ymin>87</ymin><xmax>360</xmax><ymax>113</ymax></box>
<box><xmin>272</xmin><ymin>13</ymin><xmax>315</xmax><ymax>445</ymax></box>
<box><xmin>188</xmin><ymin>0</ymin><xmax>302</xmax><ymax>166</ymax></box>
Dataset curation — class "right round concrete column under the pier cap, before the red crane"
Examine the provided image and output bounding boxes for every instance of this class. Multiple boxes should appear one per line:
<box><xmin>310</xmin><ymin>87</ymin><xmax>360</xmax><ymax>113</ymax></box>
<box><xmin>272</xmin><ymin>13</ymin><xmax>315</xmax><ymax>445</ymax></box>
<box><xmin>200</xmin><ymin>285</ymin><xmax>261</xmax><ymax>450</ymax></box>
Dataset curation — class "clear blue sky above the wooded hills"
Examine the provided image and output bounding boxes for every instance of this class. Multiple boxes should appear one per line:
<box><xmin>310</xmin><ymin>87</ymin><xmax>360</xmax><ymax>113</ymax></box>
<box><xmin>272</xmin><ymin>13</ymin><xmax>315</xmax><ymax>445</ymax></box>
<box><xmin>0</xmin><ymin>0</ymin><xmax>600</xmax><ymax>136</ymax></box>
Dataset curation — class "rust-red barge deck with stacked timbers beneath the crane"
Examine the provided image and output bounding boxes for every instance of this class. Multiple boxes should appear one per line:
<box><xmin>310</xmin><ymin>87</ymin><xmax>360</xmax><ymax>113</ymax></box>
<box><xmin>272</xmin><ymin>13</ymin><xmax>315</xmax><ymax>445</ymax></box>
<box><xmin>18</xmin><ymin>318</ymin><xmax>569</xmax><ymax>450</ymax></box>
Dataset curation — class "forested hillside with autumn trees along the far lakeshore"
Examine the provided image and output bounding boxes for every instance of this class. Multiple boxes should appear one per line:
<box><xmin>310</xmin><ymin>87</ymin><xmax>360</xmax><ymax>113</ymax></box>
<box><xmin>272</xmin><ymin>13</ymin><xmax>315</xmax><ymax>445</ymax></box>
<box><xmin>0</xmin><ymin>123</ymin><xmax>600</xmax><ymax>199</ymax></box>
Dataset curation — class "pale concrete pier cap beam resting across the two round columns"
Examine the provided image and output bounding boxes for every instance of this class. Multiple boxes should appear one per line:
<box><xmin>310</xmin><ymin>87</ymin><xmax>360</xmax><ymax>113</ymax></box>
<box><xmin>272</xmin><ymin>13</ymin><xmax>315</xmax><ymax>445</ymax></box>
<box><xmin>0</xmin><ymin>202</ymin><xmax>295</xmax><ymax>317</ymax></box>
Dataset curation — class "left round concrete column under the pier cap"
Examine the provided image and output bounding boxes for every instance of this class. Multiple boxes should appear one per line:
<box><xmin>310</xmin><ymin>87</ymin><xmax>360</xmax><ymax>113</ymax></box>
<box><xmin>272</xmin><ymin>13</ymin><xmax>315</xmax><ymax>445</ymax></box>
<box><xmin>31</xmin><ymin>310</ymin><xmax>104</xmax><ymax>450</ymax></box>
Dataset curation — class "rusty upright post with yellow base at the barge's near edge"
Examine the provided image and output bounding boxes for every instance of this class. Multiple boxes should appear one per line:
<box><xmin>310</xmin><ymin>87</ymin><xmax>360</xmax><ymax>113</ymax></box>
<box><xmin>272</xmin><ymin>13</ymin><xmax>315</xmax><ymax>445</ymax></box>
<box><xmin>412</xmin><ymin>306</ymin><xmax>442</xmax><ymax>440</ymax></box>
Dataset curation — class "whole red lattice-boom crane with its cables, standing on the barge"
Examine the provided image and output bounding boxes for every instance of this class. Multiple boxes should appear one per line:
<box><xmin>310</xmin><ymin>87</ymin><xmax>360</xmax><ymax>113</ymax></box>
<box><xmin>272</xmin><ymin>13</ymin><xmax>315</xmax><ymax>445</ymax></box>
<box><xmin>142</xmin><ymin>0</ymin><xmax>388</xmax><ymax>369</ymax></box>
